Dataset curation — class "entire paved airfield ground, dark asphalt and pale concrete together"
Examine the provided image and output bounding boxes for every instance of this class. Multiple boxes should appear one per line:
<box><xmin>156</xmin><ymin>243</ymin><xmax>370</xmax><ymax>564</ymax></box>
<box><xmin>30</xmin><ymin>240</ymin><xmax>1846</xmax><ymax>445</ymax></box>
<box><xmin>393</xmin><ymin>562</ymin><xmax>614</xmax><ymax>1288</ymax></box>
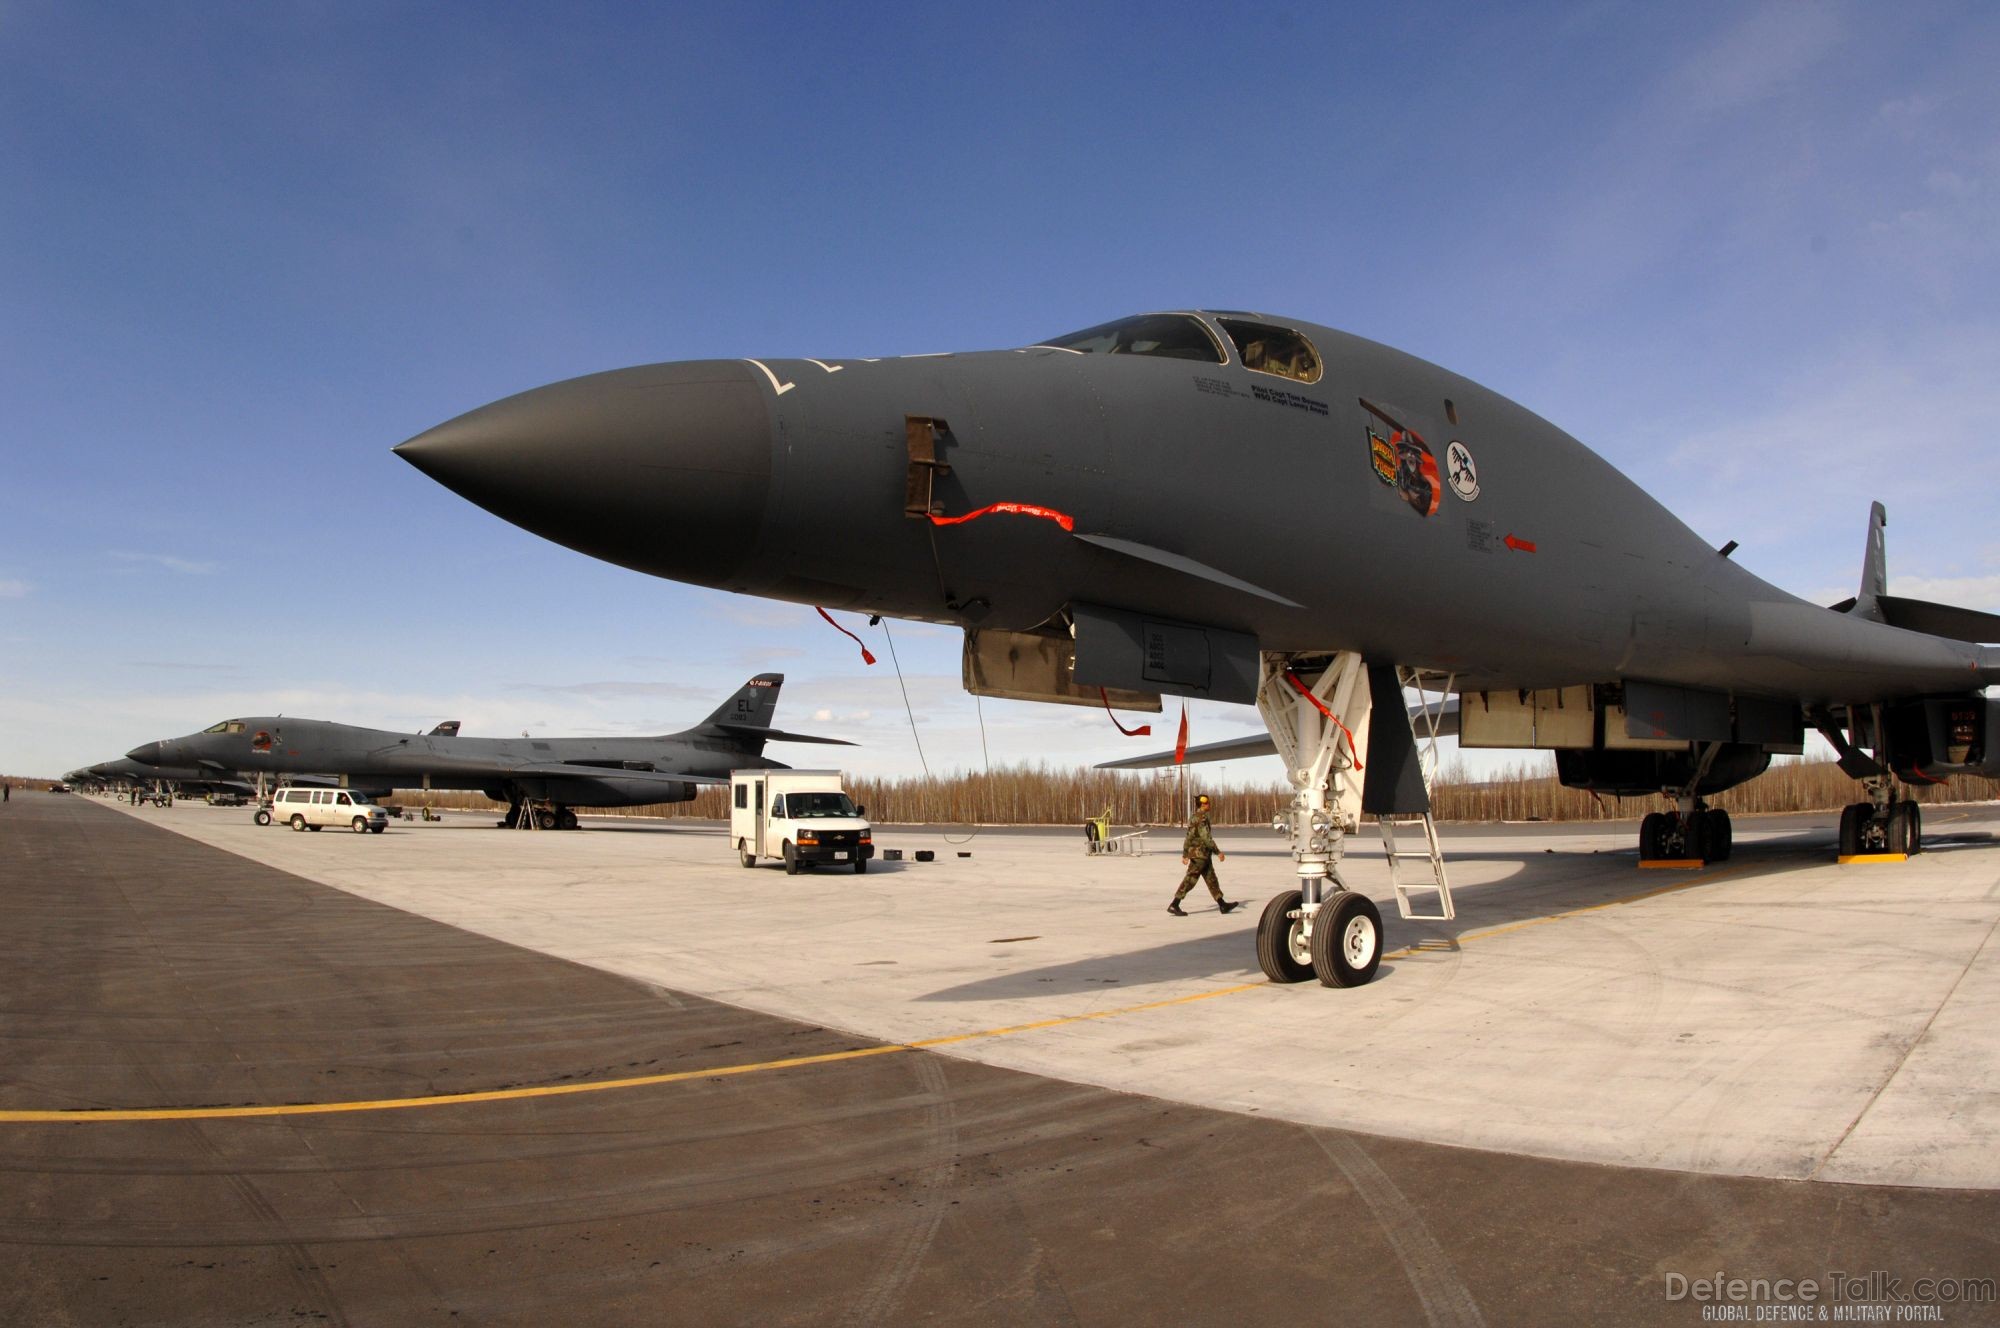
<box><xmin>0</xmin><ymin>794</ymin><xmax>2000</xmax><ymax>1324</ymax></box>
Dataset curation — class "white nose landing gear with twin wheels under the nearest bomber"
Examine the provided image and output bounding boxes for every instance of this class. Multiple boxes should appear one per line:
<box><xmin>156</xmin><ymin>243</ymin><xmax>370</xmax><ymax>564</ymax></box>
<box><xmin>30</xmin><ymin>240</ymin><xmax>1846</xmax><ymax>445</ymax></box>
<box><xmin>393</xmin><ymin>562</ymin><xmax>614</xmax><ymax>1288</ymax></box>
<box><xmin>1256</xmin><ymin>652</ymin><xmax>1382</xmax><ymax>986</ymax></box>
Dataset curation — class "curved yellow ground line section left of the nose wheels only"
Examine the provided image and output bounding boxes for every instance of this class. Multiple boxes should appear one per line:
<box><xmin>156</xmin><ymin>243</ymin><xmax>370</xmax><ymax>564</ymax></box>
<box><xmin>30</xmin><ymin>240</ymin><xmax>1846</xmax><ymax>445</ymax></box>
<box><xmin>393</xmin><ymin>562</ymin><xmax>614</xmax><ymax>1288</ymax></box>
<box><xmin>0</xmin><ymin>982</ymin><xmax>1270</xmax><ymax>1124</ymax></box>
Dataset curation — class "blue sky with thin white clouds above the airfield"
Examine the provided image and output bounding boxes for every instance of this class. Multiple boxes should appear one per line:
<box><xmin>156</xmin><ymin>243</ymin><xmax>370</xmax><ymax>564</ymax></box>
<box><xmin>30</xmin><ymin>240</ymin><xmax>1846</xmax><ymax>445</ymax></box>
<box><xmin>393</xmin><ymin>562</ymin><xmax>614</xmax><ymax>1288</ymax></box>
<box><xmin>0</xmin><ymin>0</ymin><xmax>2000</xmax><ymax>778</ymax></box>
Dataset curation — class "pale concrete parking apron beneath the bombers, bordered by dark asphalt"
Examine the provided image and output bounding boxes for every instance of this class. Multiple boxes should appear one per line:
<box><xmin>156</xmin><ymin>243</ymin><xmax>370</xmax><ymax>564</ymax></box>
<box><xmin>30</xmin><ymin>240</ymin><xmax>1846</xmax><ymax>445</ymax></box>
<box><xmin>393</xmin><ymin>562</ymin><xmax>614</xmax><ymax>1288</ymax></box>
<box><xmin>105</xmin><ymin>802</ymin><xmax>2000</xmax><ymax>1188</ymax></box>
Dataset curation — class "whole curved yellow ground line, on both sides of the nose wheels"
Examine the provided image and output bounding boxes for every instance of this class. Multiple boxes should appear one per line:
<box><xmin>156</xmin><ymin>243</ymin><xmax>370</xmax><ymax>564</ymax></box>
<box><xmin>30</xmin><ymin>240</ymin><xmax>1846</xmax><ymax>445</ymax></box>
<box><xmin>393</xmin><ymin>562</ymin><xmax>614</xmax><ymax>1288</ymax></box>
<box><xmin>0</xmin><ymin>866</ymin><xmax>1750</xmax><ymax>1124</ymax></box>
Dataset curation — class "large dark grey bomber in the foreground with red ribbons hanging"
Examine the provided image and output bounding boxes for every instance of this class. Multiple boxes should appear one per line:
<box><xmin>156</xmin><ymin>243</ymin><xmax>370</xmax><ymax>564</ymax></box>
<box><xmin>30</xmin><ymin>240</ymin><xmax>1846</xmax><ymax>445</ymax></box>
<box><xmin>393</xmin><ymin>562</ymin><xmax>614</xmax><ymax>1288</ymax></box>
<box><xmin>396</xmin><ymin>310</ymin><xmax>2000</xmax><ymax>986</ymax></box>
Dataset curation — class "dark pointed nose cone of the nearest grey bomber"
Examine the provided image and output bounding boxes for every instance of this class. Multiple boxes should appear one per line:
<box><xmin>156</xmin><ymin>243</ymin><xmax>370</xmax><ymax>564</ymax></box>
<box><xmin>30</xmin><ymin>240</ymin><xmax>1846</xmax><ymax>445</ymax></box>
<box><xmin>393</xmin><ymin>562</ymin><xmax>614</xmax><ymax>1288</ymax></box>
<box><xmin>396</xmin><ymin>360</ymin><xmax>772</xmax><ymax>582</ymax></box>
